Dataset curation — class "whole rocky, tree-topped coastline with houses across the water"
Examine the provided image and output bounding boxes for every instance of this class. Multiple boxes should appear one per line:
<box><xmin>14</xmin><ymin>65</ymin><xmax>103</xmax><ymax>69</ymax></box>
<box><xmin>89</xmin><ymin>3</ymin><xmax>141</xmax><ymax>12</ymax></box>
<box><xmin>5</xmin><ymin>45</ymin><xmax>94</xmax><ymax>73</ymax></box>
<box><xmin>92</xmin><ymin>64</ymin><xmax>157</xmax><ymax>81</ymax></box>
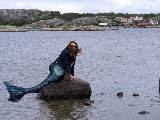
<box><xmin>0</xmin><ymin>9</ymin><xmax>160</xmax><ymax>32</ymax></box>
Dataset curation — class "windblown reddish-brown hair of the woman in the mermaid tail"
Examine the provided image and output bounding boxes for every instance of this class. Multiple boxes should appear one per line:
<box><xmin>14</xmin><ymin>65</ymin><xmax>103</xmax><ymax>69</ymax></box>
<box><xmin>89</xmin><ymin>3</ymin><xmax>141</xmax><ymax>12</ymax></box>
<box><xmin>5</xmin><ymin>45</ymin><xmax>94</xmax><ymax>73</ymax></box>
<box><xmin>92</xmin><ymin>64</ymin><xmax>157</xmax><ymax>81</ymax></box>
<box><xmin>67</xmin><ymin>40</ymin><xmax>82</xmax><ymax>58</ymax></box>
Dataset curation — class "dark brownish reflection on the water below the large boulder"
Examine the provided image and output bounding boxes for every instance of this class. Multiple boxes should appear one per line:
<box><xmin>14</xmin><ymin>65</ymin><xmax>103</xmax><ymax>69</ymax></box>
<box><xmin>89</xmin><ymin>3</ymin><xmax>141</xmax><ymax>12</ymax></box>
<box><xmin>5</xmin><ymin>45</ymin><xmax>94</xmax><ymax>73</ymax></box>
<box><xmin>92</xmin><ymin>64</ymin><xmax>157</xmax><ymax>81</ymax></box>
<box><xmin>40</xmin><ymin>100</ymin><xmax>91</xmax><ymax>120</ymax></box>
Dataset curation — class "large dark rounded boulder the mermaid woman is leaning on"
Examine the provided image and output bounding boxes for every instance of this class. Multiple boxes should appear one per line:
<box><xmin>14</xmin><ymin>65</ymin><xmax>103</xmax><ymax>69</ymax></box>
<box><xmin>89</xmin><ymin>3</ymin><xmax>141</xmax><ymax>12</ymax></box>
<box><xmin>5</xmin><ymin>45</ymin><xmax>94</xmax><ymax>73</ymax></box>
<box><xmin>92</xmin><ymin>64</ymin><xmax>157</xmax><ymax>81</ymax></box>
<box><xmin>38</xmin><ymin>78</ymin><xmax>92</xmax><ymax>100</ymax></box>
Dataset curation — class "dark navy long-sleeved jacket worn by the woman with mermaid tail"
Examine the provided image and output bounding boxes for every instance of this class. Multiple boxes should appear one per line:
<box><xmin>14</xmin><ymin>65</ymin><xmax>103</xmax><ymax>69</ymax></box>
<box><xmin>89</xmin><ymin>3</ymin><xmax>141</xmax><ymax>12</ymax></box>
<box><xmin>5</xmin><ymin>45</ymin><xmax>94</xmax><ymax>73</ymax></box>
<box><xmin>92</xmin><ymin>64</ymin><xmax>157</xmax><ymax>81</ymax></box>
<box><xmin>50</xmin><ymin>47</ymin><xmax>76</xmax><ymax>76</ymax></box>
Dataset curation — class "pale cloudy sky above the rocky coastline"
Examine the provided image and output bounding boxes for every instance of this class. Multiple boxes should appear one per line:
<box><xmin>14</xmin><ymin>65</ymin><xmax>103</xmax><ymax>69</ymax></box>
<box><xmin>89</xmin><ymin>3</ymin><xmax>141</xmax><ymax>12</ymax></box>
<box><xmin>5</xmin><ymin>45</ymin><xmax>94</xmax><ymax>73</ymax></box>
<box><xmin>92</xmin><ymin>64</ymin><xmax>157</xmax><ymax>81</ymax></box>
<box><xmin>0</xmin><ymin>0</ymin><xmax>160</xmax><ymax>14</ymax></box>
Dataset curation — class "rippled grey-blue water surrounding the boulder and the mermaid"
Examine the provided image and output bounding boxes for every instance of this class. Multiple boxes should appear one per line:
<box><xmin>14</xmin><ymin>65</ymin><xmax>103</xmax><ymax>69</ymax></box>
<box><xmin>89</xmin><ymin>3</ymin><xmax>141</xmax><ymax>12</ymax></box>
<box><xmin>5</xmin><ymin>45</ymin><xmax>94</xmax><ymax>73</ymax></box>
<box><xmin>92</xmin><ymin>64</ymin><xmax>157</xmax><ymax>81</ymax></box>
<box><xmin>0</xmin><ymin>28</ymin><xmax>160</xmax><ymax>120</ymax></box>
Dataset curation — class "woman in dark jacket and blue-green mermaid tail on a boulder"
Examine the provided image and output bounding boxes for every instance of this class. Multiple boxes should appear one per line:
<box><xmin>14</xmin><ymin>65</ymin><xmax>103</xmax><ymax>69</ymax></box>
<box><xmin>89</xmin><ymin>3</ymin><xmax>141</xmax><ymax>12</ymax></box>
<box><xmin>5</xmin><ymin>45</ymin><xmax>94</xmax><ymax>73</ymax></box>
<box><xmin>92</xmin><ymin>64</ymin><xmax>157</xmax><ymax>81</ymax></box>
<box><xmin>3</xmin><ymin>41</ymin><xmax>81</xmax><ymax>101</ymax></box>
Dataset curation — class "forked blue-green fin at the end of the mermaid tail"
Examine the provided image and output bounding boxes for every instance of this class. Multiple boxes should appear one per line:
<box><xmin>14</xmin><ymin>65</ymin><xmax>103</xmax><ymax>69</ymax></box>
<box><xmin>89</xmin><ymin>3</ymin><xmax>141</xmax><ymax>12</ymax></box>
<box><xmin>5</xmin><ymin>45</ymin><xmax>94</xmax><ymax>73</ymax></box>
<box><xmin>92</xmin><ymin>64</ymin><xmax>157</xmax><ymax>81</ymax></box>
<box><xmin>3</xmin><ymin>82</ymin><xmax>26</xmax><ymax>102</ymax></box>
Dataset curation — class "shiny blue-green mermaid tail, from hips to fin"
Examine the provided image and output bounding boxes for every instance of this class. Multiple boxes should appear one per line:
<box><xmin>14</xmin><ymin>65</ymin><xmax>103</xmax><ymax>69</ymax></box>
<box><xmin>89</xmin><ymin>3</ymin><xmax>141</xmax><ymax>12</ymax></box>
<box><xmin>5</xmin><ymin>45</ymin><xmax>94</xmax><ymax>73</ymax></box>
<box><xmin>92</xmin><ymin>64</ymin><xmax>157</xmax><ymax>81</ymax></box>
<box><xmin>3</xmin><ymin>65</ymin><xmax>64</xmax><ymax>102</ymax></box>
